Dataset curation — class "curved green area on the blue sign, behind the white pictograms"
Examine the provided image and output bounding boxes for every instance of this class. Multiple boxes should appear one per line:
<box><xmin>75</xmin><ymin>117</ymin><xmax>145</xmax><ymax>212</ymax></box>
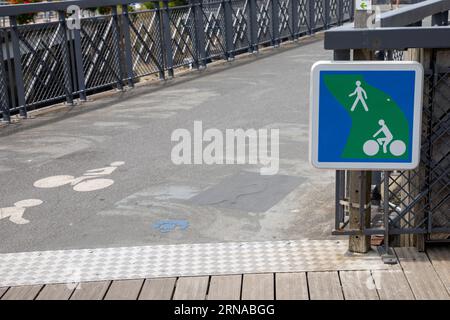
<box><xmin>324</xmin><ymin>74</ymin><xmax>409</xmax><ymax>160</ymax></box>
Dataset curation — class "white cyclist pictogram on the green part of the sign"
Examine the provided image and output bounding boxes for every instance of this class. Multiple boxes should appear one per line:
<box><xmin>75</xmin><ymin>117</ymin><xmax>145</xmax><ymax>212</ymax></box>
<box><xmin>363</xmin><ymin>119</ymin><xmax>406</xmax><ymax>157</ymax></box>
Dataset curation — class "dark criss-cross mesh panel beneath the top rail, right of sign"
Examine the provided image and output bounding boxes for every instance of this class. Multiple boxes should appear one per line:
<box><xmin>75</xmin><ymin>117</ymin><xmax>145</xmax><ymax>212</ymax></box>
<box><xmin>387</xmin><ymin>50</ymin><xmax>450</xmax><ymax>238</ymax></box>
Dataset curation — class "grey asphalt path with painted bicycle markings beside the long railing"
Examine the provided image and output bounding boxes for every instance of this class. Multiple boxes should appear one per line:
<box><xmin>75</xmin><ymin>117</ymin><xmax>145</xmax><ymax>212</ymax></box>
<box><xmin>0</xmin><ymin>36</ymin><xmax>334</xmax><ymax>253</ymax></box>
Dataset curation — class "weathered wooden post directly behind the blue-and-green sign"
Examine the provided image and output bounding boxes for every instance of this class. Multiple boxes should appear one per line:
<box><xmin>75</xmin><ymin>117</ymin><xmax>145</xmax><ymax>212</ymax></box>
<box><xmin>348</xmin><ymin>4</ymin><xmax>374</xmax><ymax>253</ymax></box>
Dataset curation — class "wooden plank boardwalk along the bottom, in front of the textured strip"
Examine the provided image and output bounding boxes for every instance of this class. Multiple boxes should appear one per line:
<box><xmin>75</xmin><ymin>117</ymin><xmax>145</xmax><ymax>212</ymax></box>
<box><xmin>0</xmin><ymin>247</ymin><xmax>450</xmax><ymax>300</ymax></box>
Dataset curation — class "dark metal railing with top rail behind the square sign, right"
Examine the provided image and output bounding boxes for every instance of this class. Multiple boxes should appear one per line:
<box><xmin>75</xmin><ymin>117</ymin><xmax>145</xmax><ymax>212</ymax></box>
<box><xmin>325</xmin><ymin>0</ymin><xmax>450</xmax><ymax>248</ymax></box>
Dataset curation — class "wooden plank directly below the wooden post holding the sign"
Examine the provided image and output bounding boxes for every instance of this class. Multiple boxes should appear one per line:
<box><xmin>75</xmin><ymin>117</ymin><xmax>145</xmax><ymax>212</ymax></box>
<box><xmin>339</xmin><ymin>271</ymin><xmax>379</xmax><ymax>300</ymax></box>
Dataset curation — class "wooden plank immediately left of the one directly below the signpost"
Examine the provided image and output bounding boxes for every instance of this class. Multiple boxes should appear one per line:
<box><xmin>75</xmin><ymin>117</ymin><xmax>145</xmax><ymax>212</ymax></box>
<box><xmin>307</xmin><ymin>271</ymin><xmax>344</xmax><ymax>300</ymax></box>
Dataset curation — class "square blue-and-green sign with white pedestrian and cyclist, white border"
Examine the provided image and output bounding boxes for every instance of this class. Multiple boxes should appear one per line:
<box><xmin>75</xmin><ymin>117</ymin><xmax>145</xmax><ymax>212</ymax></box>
<box><xmin>310</xmin><ymin>62</ymin><xmax>423</xmax><ymax>169</ymax></box>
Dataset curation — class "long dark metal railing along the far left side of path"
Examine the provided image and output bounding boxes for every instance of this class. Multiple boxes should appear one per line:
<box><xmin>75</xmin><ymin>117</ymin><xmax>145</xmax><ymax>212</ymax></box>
<box><xmin>0</xmin><ymin>0</ymin><xmax>353</xmax><ymax>121</ymax></box>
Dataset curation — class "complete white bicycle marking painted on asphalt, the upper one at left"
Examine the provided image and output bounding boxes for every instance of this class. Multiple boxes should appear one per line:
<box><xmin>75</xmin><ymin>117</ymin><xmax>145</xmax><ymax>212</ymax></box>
<box><xmin>33</xmin><ymin>161</ymin><xmax>125</xmax><ymax>192</ymax></box>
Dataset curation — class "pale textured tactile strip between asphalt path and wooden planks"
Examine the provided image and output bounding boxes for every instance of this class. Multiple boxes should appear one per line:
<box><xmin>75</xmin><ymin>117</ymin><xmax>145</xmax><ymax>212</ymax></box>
<box><xmin>0</xmin><ymin>240</ymin><xmax>386</xmax><ymax>287</ymax></box>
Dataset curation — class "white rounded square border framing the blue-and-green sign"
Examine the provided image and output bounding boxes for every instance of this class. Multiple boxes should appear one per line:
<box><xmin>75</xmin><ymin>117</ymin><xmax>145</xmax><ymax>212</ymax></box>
<box><xmin>309</xmin><ymin>61</ymin><xmax>424</xmax><ymax>171</ymax></box>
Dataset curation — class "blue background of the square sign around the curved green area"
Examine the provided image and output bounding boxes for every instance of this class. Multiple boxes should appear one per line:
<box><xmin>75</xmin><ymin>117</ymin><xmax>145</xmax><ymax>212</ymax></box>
<box><xmin>318</xmin><ymin>70</ymin><xmax>415</xmax><ymax>162</ymax></box>
